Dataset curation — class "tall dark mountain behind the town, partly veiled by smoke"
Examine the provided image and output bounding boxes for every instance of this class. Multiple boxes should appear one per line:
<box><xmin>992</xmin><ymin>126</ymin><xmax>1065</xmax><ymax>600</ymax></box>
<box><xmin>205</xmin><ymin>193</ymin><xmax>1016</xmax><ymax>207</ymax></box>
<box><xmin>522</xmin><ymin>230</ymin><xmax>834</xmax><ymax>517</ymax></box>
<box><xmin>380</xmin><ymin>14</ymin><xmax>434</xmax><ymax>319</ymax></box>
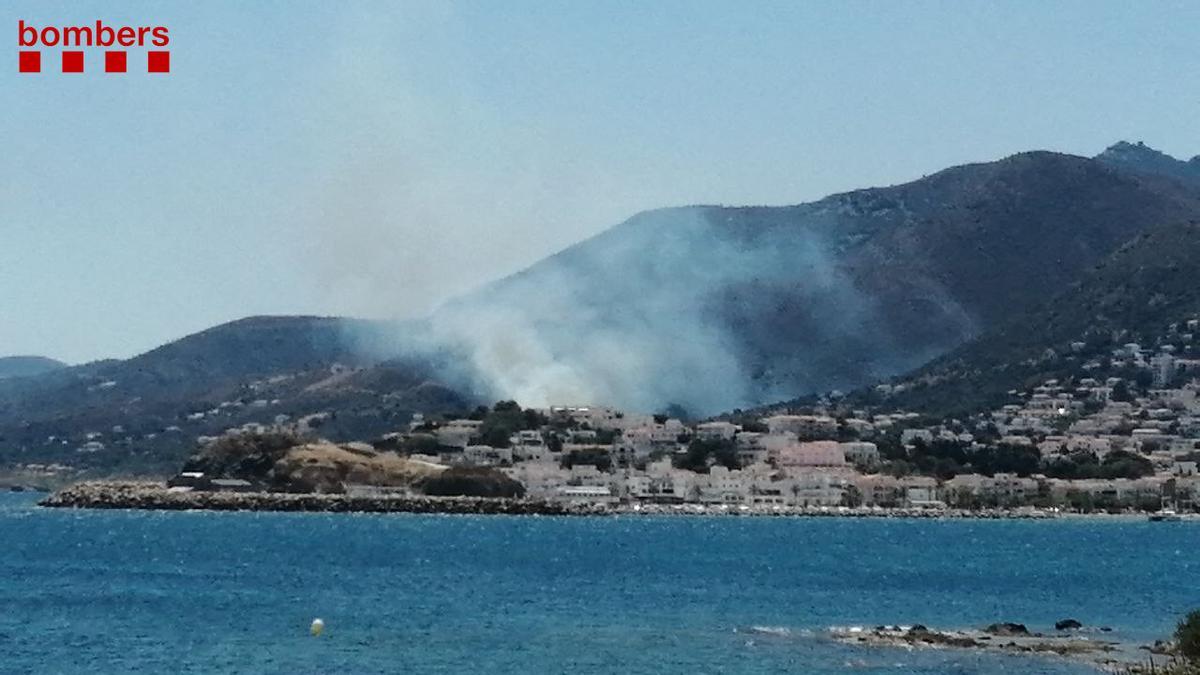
<box><xmin>433</xmin><ymin>145</ymin><xmax>1200</xmax><ymax>413</ymax></box>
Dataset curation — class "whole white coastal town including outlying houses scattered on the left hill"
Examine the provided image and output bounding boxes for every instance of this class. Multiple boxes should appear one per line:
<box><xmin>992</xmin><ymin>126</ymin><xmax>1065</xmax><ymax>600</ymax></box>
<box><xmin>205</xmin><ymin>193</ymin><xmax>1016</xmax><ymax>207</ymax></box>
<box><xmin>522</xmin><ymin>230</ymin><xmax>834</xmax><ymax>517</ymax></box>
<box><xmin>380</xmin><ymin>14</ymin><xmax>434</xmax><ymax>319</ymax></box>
<box><xmin>26</xmin><ymin>319</ymin><xmax>1200</xmax><ymax>519</ymax></box>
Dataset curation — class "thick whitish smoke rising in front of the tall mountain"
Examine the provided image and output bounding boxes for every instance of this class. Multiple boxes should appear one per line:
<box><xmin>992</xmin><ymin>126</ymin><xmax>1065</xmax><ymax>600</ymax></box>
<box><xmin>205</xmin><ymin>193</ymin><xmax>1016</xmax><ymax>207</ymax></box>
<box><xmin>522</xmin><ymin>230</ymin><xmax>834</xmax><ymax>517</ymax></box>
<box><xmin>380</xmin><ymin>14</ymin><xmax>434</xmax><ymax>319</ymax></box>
<box><xmin>412</xmin><ymin>208</ymin><xmax>859</xmax><ymax>413</ymax></box>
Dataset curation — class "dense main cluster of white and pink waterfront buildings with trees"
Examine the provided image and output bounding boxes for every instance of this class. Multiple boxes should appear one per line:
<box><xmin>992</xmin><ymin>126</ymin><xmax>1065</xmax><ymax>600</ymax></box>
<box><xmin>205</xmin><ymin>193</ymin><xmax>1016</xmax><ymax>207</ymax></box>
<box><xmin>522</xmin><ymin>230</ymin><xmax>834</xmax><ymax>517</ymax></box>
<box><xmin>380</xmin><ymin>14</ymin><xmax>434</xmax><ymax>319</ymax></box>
<box><xmin>381</xmin><ymin>381</ymin><xmax>1200</xmax><ymax>510</ymax></box>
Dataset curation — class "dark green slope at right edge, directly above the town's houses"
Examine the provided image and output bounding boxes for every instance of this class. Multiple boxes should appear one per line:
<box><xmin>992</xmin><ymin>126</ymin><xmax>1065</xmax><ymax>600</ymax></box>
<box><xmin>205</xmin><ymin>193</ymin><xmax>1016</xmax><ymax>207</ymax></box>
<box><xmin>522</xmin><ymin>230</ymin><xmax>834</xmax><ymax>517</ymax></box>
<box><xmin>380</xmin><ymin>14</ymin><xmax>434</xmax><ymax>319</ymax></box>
<box><xmin>860</xmin><ymin>220</ymin><xmax>1200</xmax><ymax>416</ymax></box>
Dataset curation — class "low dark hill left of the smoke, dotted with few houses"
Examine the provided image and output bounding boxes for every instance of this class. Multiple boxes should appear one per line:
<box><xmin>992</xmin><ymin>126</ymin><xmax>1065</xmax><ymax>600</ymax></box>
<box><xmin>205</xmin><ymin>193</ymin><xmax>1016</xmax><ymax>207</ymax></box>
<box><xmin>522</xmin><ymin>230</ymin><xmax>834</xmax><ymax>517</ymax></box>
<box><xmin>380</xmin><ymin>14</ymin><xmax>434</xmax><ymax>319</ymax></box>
<box><xmin>0</xmin><ymin>317</ymin><xmax>469</xmax><ymax>473</ymax></box>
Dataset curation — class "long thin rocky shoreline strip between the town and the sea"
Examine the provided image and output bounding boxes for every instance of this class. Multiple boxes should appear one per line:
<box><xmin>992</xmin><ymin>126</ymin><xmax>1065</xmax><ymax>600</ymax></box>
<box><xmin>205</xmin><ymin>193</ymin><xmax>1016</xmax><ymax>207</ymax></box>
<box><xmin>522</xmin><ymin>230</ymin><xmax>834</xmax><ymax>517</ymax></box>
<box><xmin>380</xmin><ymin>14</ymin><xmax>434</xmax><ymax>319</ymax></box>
<box><xmin>37</xmin><ymin>480</ymin><xmax>1190</xmax><ymax>521</ymax></box>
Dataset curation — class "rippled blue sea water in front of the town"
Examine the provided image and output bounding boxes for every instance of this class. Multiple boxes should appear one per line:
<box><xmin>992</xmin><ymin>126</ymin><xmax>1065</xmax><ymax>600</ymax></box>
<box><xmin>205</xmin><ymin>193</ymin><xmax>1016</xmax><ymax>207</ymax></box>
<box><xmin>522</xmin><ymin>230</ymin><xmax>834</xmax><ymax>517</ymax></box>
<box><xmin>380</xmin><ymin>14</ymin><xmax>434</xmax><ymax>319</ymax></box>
<box><xmin>0</xmin><ymin>494</ymin><xmax>1200</xmax><ymax>675</ymax></box>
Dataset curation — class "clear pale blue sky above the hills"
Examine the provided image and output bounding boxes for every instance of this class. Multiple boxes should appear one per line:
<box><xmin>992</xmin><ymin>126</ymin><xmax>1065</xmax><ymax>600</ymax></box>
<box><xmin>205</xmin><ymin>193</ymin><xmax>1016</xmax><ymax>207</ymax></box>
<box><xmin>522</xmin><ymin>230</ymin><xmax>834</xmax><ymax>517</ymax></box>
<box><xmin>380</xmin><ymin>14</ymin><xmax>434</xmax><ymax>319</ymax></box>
<box><xmin>0</xmin><ymin>0</ymin><xmax>1200</xmax><ymax>363</ymax></box>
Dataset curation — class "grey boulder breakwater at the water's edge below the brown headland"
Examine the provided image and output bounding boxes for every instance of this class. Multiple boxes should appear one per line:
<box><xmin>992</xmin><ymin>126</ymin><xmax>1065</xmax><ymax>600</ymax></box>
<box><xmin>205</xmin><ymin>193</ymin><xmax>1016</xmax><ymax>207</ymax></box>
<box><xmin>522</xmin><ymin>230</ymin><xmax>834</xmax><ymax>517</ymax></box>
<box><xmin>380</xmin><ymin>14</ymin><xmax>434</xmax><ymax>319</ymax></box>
<box><xmin>38</xmin><ymin>480</ymin><xmax>607</xmax><ymax>515</ymax></box>
